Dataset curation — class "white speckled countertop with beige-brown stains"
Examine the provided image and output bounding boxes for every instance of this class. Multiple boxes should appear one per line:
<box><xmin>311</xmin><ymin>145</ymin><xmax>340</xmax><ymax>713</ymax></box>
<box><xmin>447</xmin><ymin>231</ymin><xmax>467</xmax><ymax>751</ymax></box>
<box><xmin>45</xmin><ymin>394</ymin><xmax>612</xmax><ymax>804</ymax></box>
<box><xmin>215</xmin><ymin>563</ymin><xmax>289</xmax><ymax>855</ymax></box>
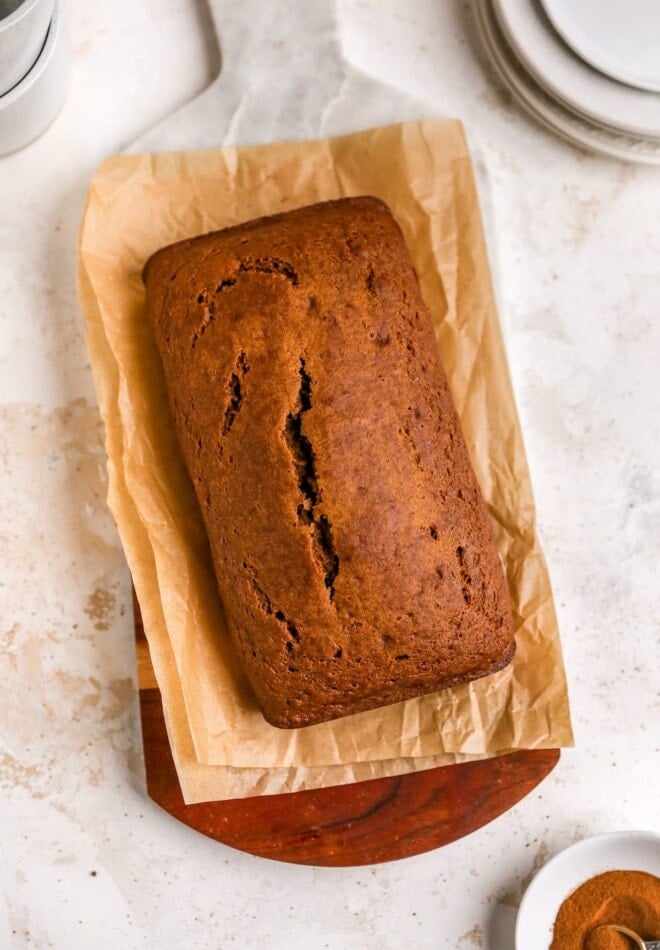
<box><xmin>0</xmin><ymin>0</ymin><xmax>660</xmax><ymax>950</ymax></box>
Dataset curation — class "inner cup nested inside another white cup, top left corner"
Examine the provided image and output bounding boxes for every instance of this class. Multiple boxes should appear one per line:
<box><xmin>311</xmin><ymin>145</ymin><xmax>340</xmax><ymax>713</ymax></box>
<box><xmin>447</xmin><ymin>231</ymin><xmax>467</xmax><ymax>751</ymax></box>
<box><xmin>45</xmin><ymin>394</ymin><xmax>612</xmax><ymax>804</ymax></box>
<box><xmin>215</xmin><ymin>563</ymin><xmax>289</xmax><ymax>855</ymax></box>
<box><xmin>0</xmin><ymin>0</ymin><xmax>55</xmax><ymax>96</ymax></box>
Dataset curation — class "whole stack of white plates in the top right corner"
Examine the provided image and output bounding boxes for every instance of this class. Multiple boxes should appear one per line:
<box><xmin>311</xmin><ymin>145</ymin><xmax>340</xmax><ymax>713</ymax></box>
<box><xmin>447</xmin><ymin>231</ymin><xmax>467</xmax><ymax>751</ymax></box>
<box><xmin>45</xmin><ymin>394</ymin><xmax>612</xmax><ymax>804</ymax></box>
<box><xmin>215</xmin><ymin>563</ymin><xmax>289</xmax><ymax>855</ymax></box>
<box><xmin>474</xmin><ymin>0</ymin><xmax>660</xmax><ymax>164</ymax></box>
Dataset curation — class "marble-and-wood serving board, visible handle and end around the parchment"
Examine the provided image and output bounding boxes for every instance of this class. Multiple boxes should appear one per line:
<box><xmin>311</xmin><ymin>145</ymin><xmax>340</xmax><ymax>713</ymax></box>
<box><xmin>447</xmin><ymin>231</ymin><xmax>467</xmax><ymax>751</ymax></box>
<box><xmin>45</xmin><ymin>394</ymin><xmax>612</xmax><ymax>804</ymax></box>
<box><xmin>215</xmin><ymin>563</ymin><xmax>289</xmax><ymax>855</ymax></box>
<box><xmin>130</xmin><ymin>0</ymin><xmax>559</xmax><ymax>866</ymax></box>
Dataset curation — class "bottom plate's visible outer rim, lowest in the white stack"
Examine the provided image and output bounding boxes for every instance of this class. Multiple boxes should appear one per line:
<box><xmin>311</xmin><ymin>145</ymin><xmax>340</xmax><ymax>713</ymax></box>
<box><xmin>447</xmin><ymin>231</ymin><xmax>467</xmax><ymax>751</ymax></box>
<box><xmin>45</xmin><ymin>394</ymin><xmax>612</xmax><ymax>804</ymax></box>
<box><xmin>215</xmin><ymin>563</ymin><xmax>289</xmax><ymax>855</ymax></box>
<box><xmin>474</xmin><ymin>0</ymin><xmax>660</xmax><ymax>165</ymax></box>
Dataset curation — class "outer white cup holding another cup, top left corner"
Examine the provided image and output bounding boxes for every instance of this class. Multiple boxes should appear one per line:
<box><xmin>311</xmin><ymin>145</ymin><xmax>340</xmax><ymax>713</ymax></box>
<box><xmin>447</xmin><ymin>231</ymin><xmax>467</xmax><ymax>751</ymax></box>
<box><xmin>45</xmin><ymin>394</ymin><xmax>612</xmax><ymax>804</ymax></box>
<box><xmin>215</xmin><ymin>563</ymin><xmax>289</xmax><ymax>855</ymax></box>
<box><xmin>0</xmin><ymin>3</ymin><xmax>70</xmax><ymax>155</ymax></box>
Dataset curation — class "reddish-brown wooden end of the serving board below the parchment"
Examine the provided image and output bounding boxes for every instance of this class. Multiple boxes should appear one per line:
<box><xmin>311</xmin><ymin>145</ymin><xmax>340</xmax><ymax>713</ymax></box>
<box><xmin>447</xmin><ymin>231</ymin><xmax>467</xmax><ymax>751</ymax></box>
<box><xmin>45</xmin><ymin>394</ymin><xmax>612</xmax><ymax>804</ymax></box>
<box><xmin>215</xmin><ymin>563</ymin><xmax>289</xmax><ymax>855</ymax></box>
<box><xmin>135</xmin><ymin>602</ymin><xmax>559</xmax><ymax>867</ymax></box>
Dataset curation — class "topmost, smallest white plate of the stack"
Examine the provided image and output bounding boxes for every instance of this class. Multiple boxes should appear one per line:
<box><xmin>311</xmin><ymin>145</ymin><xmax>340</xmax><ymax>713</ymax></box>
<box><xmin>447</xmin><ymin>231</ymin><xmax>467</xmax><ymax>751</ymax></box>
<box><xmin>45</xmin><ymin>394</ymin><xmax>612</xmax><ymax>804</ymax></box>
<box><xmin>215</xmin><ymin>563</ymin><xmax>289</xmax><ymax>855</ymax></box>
<box><xmin>541</xmin><ymin>0</ymin><xmax>660</xmax><ymax>92</ymax></box>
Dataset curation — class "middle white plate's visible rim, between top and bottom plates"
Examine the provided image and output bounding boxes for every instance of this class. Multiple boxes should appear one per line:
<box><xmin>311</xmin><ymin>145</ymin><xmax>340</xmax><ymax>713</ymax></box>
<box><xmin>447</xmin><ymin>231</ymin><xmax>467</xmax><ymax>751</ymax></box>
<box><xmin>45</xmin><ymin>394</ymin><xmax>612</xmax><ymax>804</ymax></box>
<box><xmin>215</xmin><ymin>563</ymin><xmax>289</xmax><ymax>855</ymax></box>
<box><xmin>493</xmin><ymin>0</ymin><xmax>660</xmax><ymax>138</ymax></box>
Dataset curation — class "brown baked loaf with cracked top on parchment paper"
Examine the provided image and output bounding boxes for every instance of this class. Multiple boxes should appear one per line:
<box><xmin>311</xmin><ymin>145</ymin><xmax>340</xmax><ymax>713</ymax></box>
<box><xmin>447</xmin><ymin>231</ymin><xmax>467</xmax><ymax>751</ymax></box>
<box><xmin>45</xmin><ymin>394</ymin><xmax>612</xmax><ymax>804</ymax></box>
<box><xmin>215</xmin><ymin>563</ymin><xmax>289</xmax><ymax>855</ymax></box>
<box><xmin>144</xmin><ymin>197</ymin><xmax>514</xmax><ymax>727</ymax></box>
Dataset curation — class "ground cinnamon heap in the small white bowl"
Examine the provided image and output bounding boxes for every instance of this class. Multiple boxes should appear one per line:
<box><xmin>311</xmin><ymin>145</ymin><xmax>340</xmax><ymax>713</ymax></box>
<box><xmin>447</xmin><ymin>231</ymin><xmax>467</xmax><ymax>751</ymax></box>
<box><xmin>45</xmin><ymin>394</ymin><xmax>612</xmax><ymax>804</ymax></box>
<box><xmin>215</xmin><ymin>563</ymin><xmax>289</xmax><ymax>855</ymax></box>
<box><xmin>550</xmin><ymin>871</ymin><xmax>660</xmax><ymax>950</ymax></box>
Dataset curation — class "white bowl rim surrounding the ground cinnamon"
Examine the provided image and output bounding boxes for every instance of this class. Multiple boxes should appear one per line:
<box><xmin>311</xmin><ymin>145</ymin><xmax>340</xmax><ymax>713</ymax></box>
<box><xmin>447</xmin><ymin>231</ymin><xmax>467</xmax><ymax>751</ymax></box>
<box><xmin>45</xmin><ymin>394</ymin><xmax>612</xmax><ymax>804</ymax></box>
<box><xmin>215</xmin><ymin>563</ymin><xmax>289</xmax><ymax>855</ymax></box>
<box><xmin>516</xmin><ymin>831</ymin><xmax>660</xmax><ymax>950</ymax></box>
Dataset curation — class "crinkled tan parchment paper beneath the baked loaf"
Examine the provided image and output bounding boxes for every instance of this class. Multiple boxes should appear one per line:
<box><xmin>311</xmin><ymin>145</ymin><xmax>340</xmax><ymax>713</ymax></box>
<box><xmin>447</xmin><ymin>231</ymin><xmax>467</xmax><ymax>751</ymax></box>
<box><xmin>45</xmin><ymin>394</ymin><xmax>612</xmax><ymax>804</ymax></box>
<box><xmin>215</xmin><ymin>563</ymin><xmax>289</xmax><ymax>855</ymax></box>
<box><xmin>80</xmin><ymin>121</ymin><xmax>572</xmax><ymax>801</ymax></box>
